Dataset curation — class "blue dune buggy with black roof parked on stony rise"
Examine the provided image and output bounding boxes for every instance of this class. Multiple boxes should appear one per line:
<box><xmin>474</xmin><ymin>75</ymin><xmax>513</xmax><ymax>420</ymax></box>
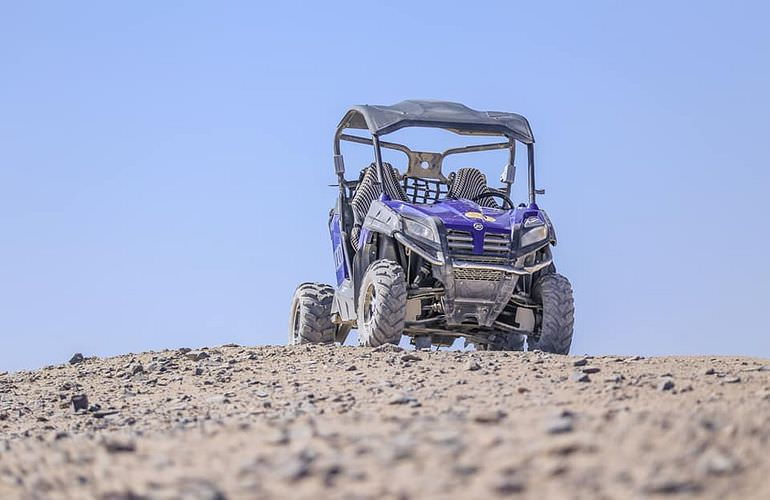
<box><xmin>289</xmin><ymin>101</ymin><xmax>574</xmax><ymax>354</ymax></box>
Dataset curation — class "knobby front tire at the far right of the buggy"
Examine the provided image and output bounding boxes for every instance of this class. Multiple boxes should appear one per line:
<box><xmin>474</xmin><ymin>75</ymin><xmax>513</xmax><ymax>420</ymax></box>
<box><xmin>529</xmin><ymin>273</ymin><xmax>575</xmax><ymax>354</ymax></box>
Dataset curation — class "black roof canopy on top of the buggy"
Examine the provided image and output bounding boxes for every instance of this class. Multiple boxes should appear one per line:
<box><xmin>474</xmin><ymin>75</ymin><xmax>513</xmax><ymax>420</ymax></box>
<box><xmin>337</xmin><ymin>100</ymin><xmax>535</xmax><ymax>144</ymax></box>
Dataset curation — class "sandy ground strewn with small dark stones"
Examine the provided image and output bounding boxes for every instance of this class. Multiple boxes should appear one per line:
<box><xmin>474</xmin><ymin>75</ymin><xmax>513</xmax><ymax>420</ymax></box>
<box><xmin>0</xmin><ymin>346</ymin><xmax>770</xmax><ymax>500</ymax></box>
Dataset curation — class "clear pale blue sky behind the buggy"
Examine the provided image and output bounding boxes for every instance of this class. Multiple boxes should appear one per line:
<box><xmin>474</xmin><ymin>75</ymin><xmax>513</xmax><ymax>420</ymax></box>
<box><xmin>0</xmin><ymin>1</ymin><xmax>770</xmax><ymax>371</ymax></box>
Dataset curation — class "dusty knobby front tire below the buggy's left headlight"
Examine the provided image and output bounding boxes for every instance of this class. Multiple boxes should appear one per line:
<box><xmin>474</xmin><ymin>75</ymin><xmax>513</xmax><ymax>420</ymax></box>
<box><xmin>358</xmin><ymin>260</ymin><xmax>406</xmax><ymax>347</ymax></box>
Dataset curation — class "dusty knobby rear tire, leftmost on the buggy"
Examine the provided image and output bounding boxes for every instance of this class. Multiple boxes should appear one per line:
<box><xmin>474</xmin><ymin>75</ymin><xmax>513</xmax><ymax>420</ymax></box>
<box><xmin>289</xmin><ymin>283</ymin><xmax>337</xmax><ymax>345</ymax></box>
